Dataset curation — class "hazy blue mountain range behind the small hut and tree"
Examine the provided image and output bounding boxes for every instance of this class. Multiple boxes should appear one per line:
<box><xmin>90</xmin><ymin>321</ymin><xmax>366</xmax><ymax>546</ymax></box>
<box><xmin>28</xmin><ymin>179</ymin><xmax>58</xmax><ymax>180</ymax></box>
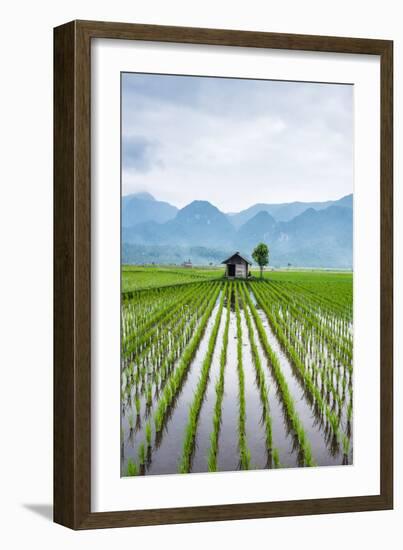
<box><xmin>122</xmin><ymin>193</ymin><xmax>353</xmax><ymax>268</ymax></box>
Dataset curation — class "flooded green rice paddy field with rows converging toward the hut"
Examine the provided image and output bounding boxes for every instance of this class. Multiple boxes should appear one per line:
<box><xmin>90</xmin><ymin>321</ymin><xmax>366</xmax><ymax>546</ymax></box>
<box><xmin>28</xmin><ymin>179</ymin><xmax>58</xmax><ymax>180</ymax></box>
<box><xmin>121</xmin><ymin>266</ymin><xmax>353</xmax><ymax>476</ymax></box>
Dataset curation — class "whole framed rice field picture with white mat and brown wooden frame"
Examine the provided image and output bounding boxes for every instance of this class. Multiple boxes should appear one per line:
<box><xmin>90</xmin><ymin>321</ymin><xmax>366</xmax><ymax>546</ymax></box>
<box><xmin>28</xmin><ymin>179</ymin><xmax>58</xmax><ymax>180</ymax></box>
<box><xmin>54</xmin><ymin>21</ymin><xmax>393</xmax><ymax>529</ymax></box>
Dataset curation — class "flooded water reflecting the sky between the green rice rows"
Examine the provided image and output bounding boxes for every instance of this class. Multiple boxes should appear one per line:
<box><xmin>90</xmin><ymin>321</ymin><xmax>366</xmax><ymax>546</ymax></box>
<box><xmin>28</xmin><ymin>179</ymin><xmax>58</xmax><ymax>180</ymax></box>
<box><xmin>121</xmin><ymin>281</ymin><xmax>352</xmax><ymax>476</ymax></box>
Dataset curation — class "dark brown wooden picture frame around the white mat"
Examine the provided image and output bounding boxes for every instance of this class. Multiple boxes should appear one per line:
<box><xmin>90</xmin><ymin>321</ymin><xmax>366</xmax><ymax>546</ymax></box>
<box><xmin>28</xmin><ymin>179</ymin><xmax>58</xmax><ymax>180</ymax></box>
<box><xmin>54</xmin><ymin>21</ymin><xmax>393</xmax><ymax>529</ymax></box>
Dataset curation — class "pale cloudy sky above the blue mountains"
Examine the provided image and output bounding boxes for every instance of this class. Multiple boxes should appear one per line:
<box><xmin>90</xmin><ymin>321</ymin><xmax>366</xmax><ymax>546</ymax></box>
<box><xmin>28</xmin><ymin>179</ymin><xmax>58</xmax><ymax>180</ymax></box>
<box><xmin>122</xmin><ymin>73</ymin><xmax>353</xmax><ymax>212</ymax></box>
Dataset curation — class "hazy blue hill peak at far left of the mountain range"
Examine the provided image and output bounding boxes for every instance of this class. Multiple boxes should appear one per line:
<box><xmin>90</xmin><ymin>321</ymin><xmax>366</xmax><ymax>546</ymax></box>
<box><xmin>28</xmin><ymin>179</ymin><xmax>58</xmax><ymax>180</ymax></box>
<box><xmin>122</xmin><ymin>193</ymin><xmax>178</xmax><ymax>227</ymax></box>
